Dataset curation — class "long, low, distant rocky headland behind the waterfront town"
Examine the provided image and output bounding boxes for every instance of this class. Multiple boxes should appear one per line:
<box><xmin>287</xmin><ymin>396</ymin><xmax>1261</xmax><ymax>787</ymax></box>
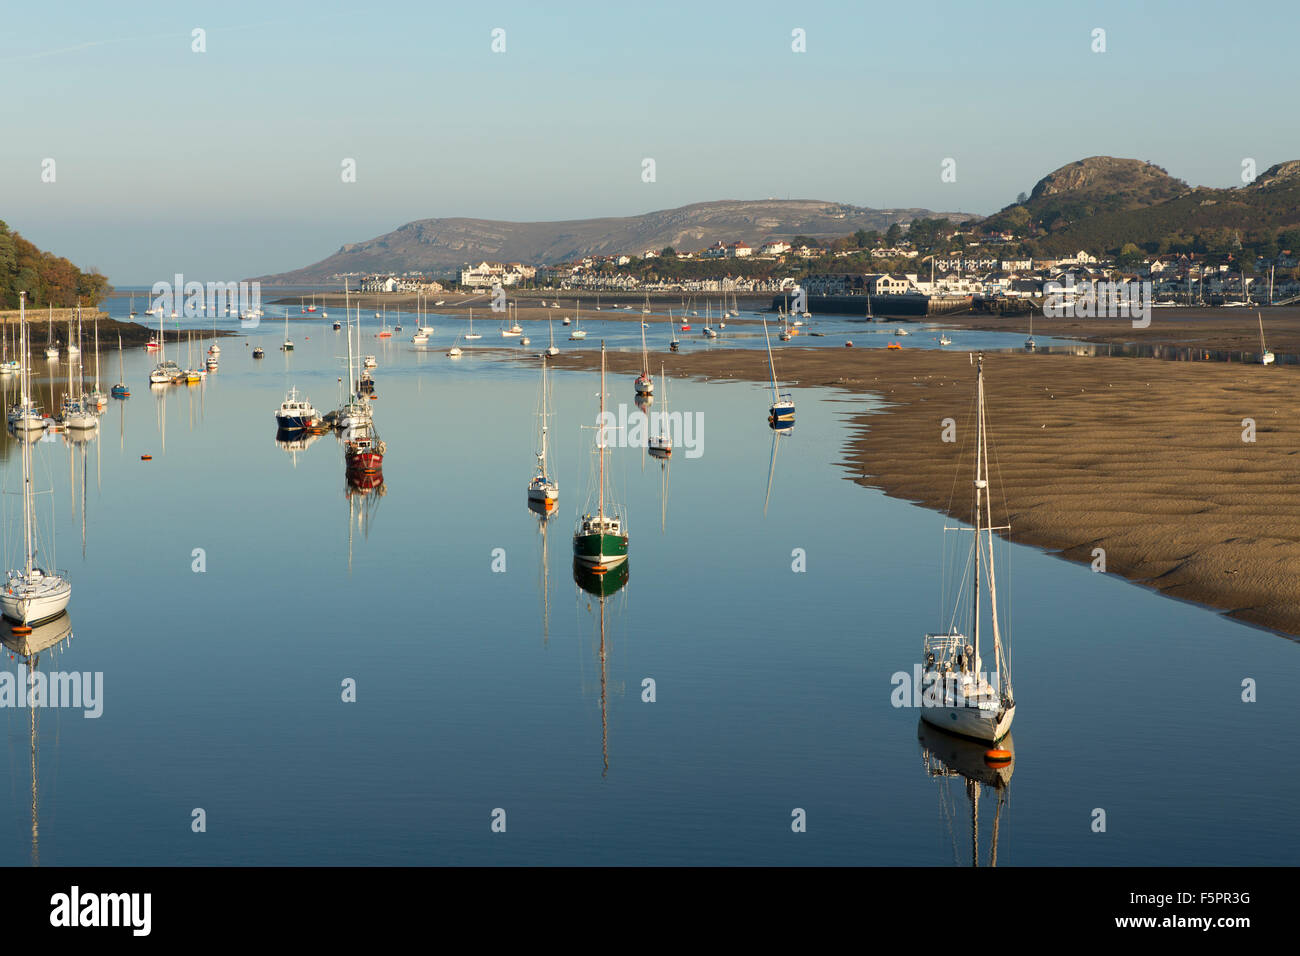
<box><xmin>248</xmin><ymin>199</ymin><xmax>972</xmax><ymax>285</ymax></box>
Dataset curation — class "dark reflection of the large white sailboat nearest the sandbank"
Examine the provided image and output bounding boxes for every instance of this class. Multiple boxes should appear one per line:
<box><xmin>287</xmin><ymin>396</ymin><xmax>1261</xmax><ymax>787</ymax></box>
<box><xmin>917</xmin><ymin>721</ymin><xmax>1015</xmax><ymax>866</ymax></box>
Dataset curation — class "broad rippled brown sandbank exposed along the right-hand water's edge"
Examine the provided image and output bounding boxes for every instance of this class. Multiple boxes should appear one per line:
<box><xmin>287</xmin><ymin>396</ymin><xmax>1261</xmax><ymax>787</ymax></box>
<box><xmin>553</xmin><ymin>345</ymin><xmax>1300</xmax><ymax>636</ymax></box>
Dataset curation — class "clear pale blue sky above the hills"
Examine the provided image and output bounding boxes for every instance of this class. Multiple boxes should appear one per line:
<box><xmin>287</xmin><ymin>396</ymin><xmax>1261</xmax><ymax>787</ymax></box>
<box><xmin>0</xmin><ymin>0</ymin><xmax>1300</xmax><ymax>286</ymax></box>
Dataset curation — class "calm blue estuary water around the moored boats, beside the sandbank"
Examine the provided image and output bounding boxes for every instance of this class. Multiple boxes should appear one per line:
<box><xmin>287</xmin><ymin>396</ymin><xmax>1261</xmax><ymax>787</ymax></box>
<box><xmin>0</xmin><ymin>323</ymin><xmax>1300</xmax><ymax>865</ymax></box>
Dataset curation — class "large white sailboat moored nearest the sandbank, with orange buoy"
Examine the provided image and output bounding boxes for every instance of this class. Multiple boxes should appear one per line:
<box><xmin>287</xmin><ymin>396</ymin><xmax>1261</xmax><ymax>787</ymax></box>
<box><xmin>920</xmin><ymin>355</ymin><xmax>1015</xmax><ymax>744</ymax></box>
